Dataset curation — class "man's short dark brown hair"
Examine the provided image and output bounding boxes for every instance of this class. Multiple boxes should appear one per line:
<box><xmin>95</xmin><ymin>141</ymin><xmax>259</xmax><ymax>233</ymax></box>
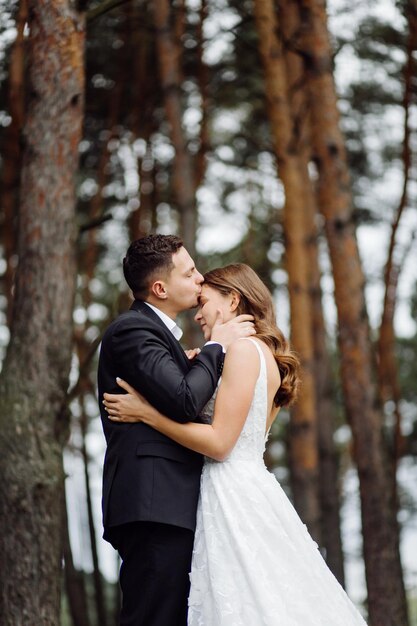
<box><xmin>123</xmin><ymin>235</ymin><xmax>184</xmax><ymax>300</ymax></box>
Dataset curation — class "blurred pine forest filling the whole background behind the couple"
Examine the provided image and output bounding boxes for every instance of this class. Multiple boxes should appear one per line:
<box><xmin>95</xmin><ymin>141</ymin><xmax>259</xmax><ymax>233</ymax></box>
<box><xmin>0</xmin><ymin>0</ymin><xmax>417</xmax><ymax>626</ymax></box>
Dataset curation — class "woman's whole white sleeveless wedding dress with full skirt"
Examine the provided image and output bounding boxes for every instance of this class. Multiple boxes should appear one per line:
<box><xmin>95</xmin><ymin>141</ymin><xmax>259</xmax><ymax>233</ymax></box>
<box><xmin>188</xmin><ymin>339</ymin><xmax>366</xmax><ymax>626</ymax></box>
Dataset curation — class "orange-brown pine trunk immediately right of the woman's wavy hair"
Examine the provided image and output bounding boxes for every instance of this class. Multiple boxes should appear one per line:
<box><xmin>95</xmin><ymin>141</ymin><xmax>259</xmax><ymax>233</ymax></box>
<box><xmin>254</xmin><ymin>0</ymin><xmax>320</xmax><ymax>542</ymax></box>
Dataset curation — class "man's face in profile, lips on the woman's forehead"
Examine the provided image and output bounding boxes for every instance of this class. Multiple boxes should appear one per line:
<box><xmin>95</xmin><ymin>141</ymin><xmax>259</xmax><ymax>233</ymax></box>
<box><xmin>165</xmin><ymin>248</ymin><xmax>204</xmax><ymax>313</ymax></box>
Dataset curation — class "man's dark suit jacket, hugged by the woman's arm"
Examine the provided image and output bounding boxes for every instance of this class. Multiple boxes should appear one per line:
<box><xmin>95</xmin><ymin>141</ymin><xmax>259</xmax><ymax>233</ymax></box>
<box><xmin>98</xmin><ymin>300</ymin><xmax>223</xmax><ymax>541</ymax></box>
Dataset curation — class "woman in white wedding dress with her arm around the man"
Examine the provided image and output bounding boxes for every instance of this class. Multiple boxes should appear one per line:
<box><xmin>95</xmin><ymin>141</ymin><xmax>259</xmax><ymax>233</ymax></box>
<box><xmin>104</xmin><ymin>263</ymin><xmax>365</xmax><ymax>626</ymax></box>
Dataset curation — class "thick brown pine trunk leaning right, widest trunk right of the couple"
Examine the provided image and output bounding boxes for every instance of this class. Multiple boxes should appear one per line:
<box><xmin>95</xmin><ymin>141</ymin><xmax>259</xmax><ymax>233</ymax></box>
<box><xmin>295</xmin><ymin>0</ymin><xmax>408</xmax><ymax>626</ymax></box>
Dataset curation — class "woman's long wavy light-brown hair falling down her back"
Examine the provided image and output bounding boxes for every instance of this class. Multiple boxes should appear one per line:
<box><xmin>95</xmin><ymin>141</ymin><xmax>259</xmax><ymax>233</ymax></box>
<box><xmin>204</xmin><ymin>263</ymin><xmax>300</xmax><ymax>406</ymax></box>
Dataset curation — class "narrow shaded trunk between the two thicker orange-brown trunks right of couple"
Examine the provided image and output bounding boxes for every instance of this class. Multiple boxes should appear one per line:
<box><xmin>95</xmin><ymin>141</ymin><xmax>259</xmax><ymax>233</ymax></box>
<box><xmin>278</xmin><ymin>0</ymin><xmax>344</xmax><ymax>585</ymax></box>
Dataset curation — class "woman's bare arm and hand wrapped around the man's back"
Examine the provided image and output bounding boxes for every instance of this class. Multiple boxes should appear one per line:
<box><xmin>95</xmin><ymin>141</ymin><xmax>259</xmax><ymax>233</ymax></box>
<box><xmin>104</xmin><ymin>341</ymin><xmax>259</xmax><ymax>461</ymax></box>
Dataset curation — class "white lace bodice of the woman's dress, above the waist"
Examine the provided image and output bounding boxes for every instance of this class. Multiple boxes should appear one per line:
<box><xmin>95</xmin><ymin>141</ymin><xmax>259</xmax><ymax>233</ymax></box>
<box><xmin>201</xmin><ymin>338</ymin><xmax>268</xmax><ymax>462</ymax></box>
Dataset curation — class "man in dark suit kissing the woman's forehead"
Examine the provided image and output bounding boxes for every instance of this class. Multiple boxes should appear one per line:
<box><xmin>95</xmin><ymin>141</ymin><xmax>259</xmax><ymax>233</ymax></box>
<box><xmin>98</xmin><ymin>235</ymin><xmax>254</xmax><ymax>626</ymax></box>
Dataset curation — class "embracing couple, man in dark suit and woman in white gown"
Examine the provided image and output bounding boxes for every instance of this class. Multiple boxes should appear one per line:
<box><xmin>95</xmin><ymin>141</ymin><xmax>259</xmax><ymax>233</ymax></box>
<box><xmin>98</xmin><ymin>235</ymin><xmax>365</xmax><ymax>626</ymax></box>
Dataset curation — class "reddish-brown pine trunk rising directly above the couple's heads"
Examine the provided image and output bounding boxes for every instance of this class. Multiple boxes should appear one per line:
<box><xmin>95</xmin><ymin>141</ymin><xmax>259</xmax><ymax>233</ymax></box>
<box><xmin>154</xmin><ymin>0</ymin><xmax>197</xmax><ymax>257</ymax></box>
